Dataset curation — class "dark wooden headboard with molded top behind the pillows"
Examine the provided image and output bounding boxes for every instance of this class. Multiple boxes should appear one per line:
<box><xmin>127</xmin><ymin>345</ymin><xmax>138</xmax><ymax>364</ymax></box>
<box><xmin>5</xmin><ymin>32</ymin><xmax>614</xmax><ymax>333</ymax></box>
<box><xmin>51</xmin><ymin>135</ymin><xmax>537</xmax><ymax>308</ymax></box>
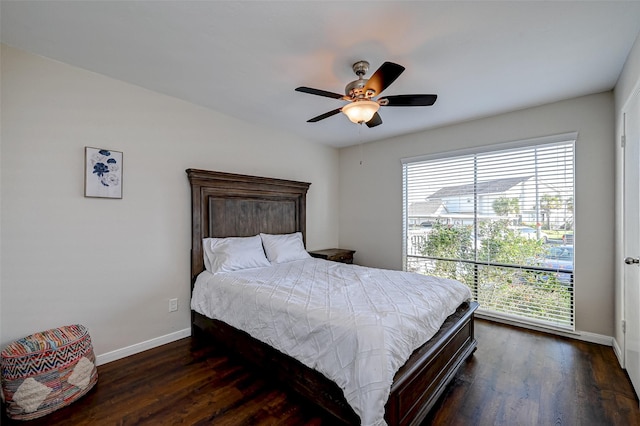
<box><xmin>187</xmin><ymin>169</ymin><xmax>310</xmax><ymax>288</ymax></box>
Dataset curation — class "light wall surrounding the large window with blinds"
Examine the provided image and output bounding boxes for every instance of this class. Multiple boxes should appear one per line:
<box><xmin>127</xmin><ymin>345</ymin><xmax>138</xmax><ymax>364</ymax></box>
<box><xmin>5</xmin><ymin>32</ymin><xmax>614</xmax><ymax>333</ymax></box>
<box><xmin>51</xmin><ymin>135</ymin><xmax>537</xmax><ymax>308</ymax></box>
<box><xmin>340</xmin><ymin>92</ymin><xmax>615</xmax><ymax>336</ymax></box>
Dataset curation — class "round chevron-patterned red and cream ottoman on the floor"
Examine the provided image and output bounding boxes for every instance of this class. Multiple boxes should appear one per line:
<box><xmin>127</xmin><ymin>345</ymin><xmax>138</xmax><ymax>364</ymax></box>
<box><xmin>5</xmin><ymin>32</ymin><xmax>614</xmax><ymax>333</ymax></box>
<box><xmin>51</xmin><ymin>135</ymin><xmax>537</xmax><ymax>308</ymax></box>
<box><xmin>0</xmin><ymin>324</ymin><xmax>98</xmax><ymax>420</ymax></box>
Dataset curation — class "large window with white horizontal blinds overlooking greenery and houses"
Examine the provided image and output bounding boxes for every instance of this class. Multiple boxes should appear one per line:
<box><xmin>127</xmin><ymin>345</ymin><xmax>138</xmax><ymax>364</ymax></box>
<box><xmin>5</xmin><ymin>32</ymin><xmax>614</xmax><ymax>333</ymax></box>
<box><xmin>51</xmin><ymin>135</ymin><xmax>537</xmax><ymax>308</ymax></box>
<box><xmin>403</xmin><ymin>134</ymin><xmax>577</xmax><ymax>330</ymax></box>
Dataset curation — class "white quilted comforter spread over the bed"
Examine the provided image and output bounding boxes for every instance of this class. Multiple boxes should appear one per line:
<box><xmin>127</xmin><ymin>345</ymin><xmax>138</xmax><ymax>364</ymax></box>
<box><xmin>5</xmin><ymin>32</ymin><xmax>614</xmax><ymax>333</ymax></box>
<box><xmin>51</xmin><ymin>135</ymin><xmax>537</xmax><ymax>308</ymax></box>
<box><xmin>191</xmin><ymin>259</ymin><xmax>471</xmax><ymax>425</ymax></box>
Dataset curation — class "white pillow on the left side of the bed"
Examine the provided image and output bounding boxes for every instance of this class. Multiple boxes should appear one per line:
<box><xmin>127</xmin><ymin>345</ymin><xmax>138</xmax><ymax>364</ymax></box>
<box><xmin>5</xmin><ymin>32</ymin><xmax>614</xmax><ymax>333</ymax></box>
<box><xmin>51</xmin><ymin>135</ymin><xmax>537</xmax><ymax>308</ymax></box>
<box><xmin>202</xmin><ymin>235</ymin><xmax>270</xmax><ymax>274</ymax></box>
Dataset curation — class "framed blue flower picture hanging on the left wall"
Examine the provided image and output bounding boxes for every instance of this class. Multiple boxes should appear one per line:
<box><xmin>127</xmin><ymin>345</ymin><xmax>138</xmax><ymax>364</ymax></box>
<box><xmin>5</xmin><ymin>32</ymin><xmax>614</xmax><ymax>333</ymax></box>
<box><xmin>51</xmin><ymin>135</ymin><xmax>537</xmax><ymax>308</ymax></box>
<box><xmin>84</xmin><ymin>146</ymin><xmax>122</xmax><ymax>198</ymax></box>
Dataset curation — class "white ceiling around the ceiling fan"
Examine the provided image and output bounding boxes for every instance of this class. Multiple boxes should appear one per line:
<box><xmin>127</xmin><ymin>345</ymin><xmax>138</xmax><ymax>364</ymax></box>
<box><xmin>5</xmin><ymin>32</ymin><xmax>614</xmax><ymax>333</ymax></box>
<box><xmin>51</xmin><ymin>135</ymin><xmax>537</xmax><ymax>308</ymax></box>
<box><xmin>0</xmin><ymin>0</ymin><xmax>640</xmax><ymax>147</ymax></box>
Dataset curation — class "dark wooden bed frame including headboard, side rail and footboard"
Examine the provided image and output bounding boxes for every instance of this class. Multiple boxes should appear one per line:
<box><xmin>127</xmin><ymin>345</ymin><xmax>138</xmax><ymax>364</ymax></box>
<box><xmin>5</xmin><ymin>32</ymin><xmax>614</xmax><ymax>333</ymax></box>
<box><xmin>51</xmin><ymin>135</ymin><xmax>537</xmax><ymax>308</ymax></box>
<box><xmin>187</xmin><ymin>169</ymin><xmax>478</xmax><ymax>425</ymax></box>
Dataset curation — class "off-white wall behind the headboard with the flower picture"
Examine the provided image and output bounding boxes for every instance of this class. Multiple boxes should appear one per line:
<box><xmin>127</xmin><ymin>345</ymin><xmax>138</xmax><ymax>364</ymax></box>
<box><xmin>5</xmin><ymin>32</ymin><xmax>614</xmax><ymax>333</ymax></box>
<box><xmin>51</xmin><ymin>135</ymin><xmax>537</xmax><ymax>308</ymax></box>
<box><xmin>0</xmin><ymin>45</ymin><xmax>338</xmax><ymax>355</ymax></box>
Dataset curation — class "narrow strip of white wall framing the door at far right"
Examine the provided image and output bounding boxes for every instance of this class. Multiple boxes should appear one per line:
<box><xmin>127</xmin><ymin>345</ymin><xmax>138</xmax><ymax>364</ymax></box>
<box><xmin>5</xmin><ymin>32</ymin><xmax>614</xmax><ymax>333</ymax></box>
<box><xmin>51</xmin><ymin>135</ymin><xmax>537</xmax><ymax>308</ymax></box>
<box><xmin>614</xmin><ymin>31</ymin><xmax>640</xmax><ymax>362</ymax></box>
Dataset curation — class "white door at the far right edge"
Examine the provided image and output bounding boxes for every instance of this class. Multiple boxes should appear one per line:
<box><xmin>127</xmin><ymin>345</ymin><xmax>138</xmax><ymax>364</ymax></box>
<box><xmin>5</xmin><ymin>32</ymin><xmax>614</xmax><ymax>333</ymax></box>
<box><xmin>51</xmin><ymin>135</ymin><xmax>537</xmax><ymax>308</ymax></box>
<box><xmin>624</xmin><ymin>90</ymin><xmax>640</xmax><ymax>395</ymax></box>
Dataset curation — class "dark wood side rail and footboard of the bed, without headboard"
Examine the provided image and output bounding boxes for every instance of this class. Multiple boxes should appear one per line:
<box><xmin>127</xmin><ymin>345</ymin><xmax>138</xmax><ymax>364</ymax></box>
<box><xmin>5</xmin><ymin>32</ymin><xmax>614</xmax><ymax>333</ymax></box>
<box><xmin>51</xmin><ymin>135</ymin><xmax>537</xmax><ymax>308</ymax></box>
<box><xmin>193</xmin><ymin>302</ymin><xmax>478</xmax><ymax>425</ymax></box>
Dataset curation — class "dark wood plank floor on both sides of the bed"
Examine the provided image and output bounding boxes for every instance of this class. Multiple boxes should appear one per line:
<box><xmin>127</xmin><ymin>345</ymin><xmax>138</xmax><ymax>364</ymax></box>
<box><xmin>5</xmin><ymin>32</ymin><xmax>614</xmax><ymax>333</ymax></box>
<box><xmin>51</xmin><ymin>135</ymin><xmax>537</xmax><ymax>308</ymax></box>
<box><xmin>2</xmin><ymin>320</ymin><xmax>640</xmax><ymax>426</ymax></box>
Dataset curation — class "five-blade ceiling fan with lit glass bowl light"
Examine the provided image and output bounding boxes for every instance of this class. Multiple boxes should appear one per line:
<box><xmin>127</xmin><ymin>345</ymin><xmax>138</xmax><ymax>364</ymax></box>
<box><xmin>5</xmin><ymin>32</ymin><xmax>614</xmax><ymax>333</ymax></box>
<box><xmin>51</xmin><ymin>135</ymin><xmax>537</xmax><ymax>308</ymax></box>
<box><xmin>296</xmin><ymin>61</ymin><xmax>438</xmax><ymax>127</ymax></box>
